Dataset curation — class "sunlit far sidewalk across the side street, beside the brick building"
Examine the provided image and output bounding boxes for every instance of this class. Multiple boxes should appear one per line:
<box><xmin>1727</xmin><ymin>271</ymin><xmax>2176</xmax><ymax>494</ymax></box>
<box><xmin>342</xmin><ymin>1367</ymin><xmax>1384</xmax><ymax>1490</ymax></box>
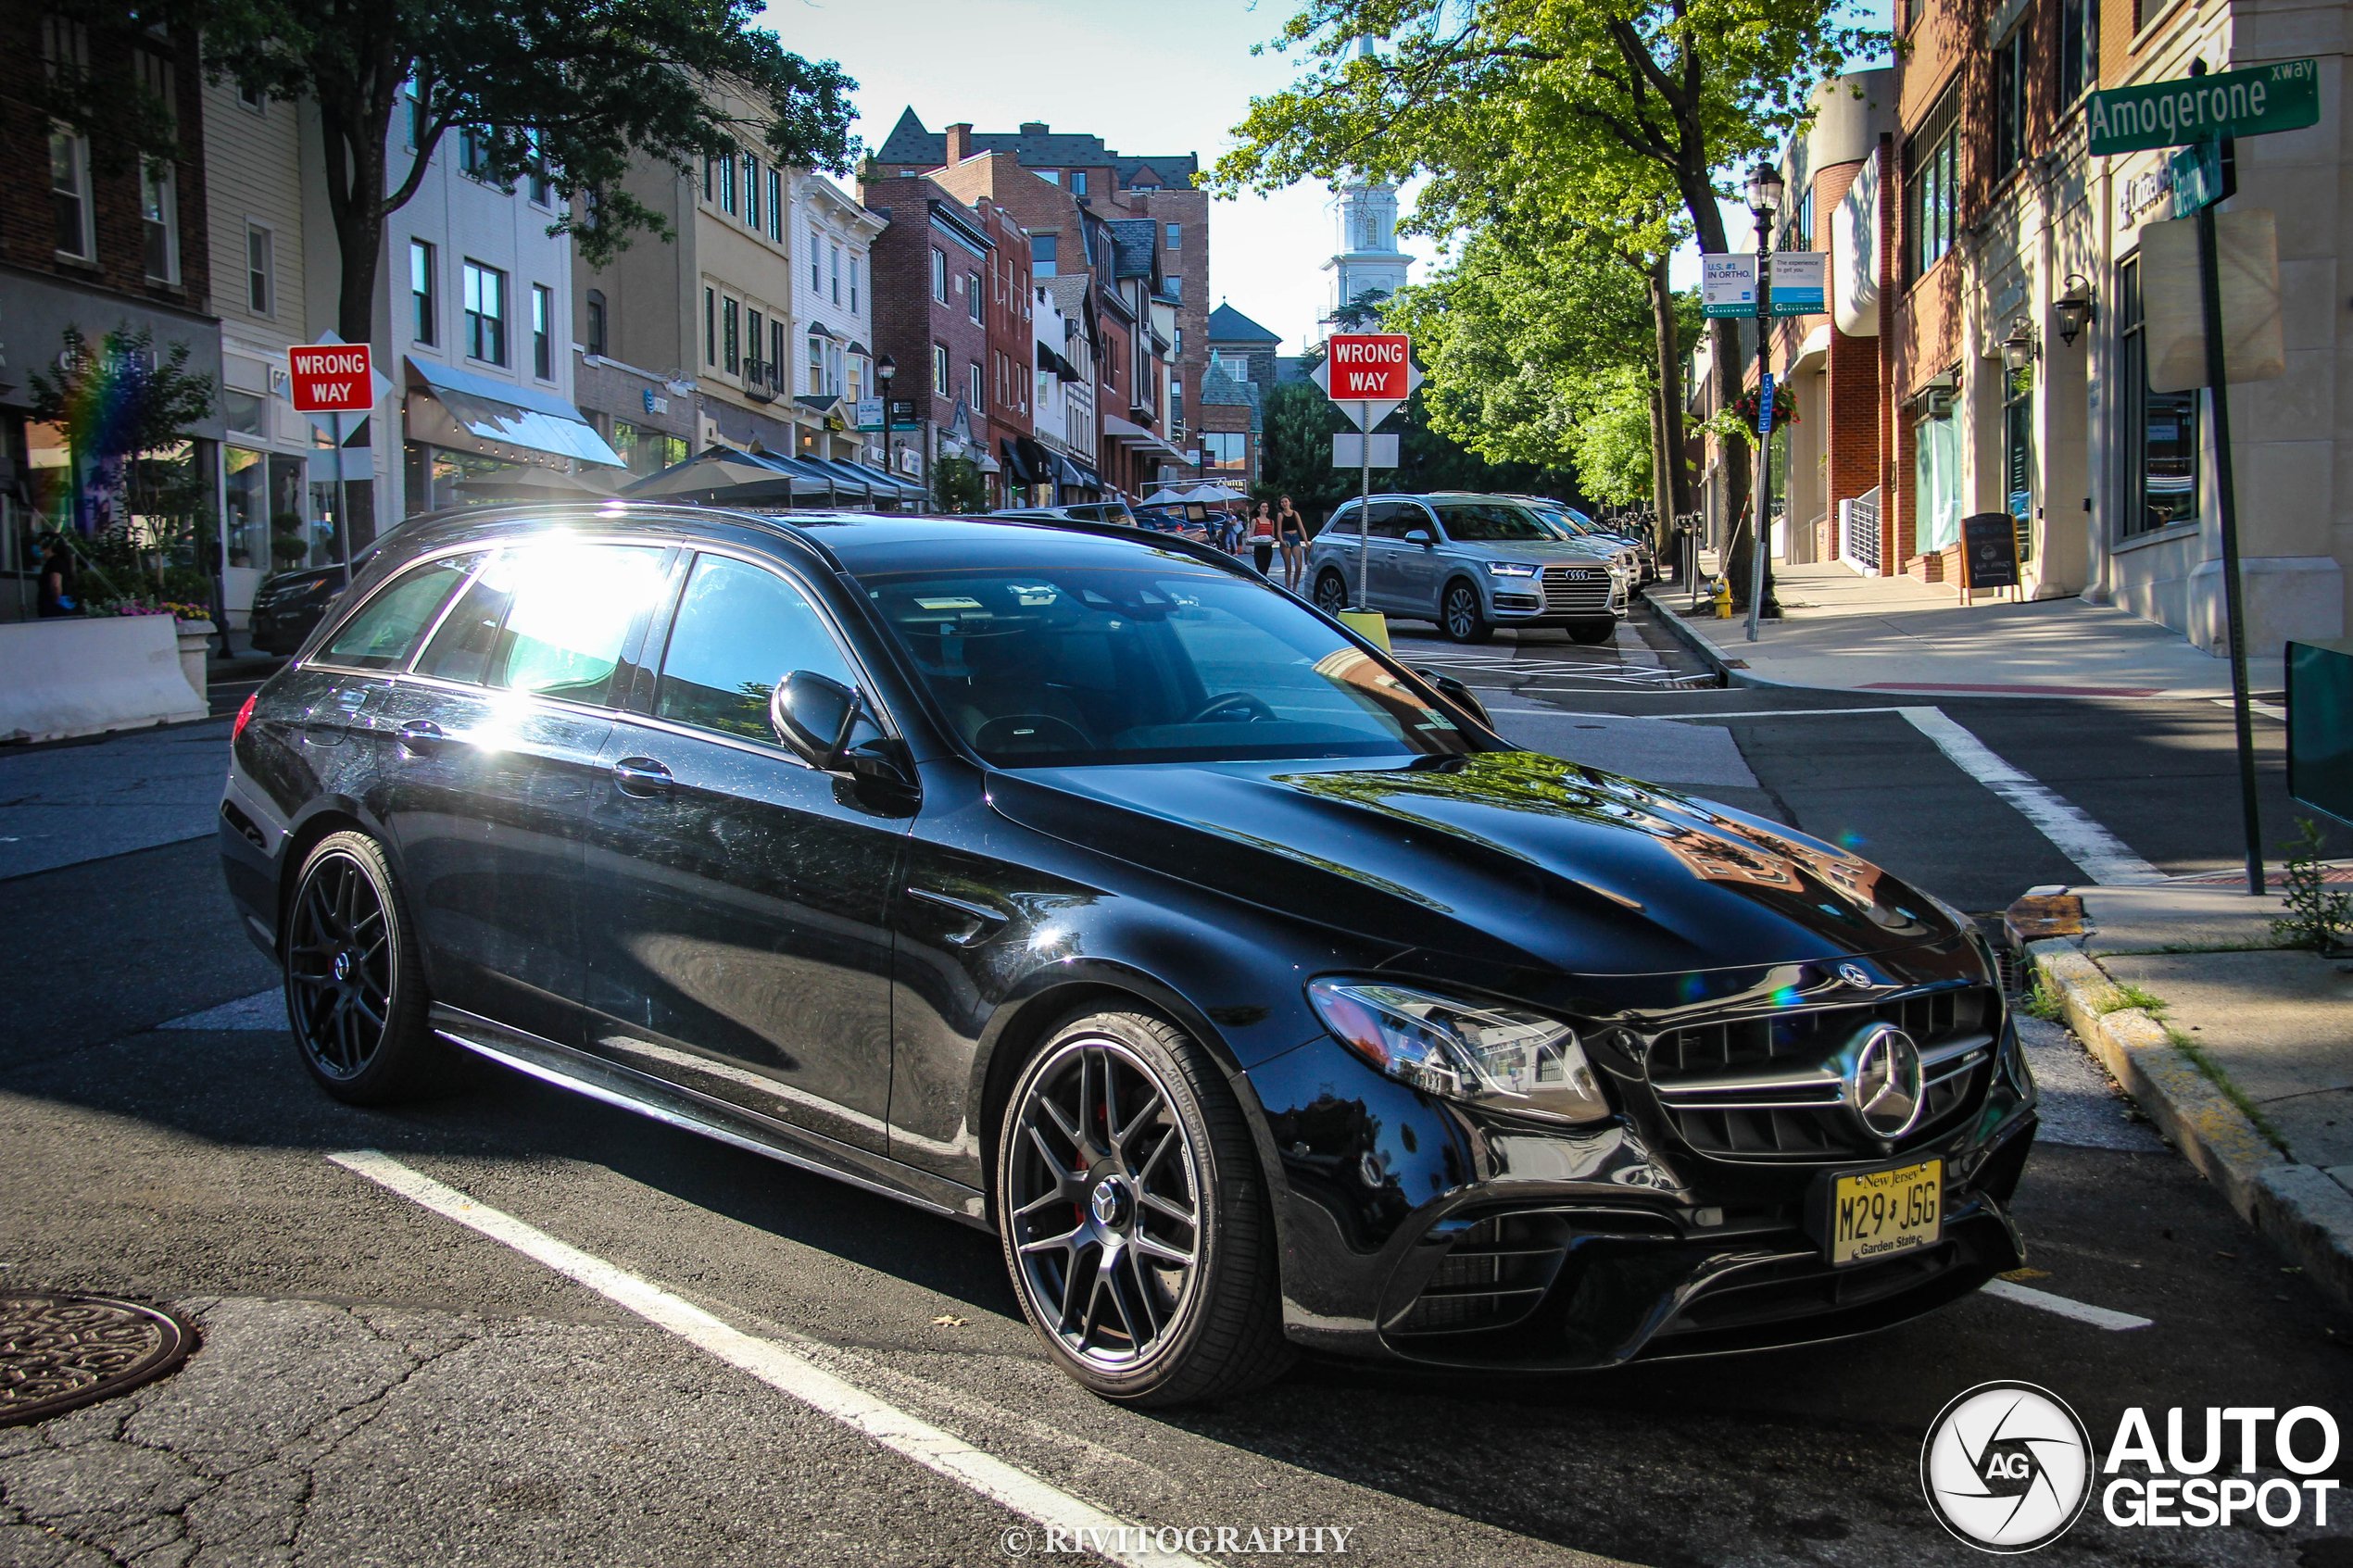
<box><xmin>1647</xmin><ymin>558</ymin><xmax>2240</xmax><ymax>698</ymax></box>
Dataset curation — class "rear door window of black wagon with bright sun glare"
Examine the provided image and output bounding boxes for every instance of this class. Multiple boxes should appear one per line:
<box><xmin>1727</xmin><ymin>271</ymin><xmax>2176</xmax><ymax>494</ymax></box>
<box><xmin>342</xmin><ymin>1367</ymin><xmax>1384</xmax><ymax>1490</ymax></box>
<box><xmin>417</xmin><ymin>543</ymin><xmax>661</xmax><ymax>703</ymax></box>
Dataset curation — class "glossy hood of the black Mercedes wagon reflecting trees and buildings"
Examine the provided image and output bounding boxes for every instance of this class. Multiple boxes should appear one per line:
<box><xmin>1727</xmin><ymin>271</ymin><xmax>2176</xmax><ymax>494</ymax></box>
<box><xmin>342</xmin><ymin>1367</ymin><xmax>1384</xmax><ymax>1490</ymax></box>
<box><xmin>990</xmin><ymin>752</ymin><xmax>1957</xmax><ymax>975</ymax></box>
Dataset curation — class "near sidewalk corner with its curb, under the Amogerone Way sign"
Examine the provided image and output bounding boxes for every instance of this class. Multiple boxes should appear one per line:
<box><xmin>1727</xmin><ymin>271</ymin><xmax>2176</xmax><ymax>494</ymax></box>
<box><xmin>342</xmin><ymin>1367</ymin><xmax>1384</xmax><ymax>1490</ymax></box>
<box><xmin>2009</xmin><ymin>884</ymin><xmax>2353</xmax><ymax>1310</ymax></box>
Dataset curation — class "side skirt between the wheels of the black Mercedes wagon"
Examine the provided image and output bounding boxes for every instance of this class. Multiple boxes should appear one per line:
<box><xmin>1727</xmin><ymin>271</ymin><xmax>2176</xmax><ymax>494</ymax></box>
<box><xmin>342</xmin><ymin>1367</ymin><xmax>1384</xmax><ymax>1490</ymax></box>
<box><xmin>433</xmin><ymin>1001</ymin><xmax>990</xmax><ymax>1229</ymax></box>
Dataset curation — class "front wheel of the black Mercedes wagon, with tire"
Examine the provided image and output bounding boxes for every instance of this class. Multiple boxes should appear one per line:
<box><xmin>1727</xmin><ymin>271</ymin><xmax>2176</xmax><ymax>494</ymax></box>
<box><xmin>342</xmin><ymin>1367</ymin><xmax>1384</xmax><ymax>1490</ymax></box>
<box><xmin>995</xmin><ymin>1013</ymin><xmax>1291</xmax><ymax>1406</ymax></box>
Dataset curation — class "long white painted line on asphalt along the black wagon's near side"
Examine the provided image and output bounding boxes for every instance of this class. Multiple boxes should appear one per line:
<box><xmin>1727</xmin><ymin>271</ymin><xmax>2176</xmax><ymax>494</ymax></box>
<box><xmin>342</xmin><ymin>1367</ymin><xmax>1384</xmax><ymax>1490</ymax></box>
<box><xmin>327</xmin><ymin>1149</ymin><xmax>1210</xmax><ymax>1568</ymax></box>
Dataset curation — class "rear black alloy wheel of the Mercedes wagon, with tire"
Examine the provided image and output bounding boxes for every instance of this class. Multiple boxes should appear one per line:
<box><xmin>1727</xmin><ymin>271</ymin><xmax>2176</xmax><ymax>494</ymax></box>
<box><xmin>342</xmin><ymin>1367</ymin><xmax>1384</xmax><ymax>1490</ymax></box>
<box><xmin>284</xmin><ymin>833</ymin><xmax>449</xmax><ymax>1105</ymax></box>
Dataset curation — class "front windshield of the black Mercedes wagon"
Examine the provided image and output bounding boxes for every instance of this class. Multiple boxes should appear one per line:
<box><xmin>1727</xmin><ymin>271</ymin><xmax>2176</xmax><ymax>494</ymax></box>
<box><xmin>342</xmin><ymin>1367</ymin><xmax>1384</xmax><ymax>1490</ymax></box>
<box><xmin>863</xmin><ymin>559</ymin><xmax>1471</xmax><ymax>769</ymax></box>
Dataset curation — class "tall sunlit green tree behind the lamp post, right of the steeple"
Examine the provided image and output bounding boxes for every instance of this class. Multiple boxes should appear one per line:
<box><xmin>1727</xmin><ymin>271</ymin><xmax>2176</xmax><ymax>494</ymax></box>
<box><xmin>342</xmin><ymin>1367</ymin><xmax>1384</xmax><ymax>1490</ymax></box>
<box><xmin>1212</xmin><ymin>0</ymin><xmax>1887</xmax><ymax>601</ymax></box>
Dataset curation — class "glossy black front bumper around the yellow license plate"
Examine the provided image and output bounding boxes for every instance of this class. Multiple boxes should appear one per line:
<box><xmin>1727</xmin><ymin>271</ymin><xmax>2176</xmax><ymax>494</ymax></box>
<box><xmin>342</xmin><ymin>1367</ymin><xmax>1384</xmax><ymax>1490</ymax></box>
<box><xmin>1250</xmin><ymin>992</ymin><xmax>2035</xmax><ymax>1371</ymax></box>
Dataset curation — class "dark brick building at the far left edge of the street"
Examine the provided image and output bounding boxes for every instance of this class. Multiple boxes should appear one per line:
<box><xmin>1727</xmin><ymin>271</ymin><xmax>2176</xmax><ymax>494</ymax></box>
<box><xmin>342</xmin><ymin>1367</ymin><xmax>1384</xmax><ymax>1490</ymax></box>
<box><xmin>0</xmin><ymin>7</ymin><xmax>223</xmax><ymax>621</ymax></box>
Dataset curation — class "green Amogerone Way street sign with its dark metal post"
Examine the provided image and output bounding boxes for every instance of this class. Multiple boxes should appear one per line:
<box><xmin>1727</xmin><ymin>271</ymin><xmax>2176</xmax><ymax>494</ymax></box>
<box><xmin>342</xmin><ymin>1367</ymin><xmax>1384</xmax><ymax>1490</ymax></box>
<box><xmin>2084</xmin><ymin>58</ymin><xmax>2320</xmax><ymax>898</ymax></box>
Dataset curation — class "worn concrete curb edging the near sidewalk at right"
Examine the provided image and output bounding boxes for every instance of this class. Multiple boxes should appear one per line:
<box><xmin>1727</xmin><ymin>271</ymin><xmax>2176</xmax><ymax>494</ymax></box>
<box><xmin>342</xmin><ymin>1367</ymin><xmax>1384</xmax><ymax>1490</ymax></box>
<box><xmin>2026</xmin><ymin>935</ymin><xmax>2353</xmax><ymax>1311</ymax></box>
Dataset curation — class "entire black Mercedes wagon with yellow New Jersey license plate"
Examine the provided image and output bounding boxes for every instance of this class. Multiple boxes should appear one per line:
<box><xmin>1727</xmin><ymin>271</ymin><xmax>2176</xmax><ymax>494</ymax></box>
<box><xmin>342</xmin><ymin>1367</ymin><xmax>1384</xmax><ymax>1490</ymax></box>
<box><xmin>221</xmin><ymin>503</ymin><xmax>2035</xmax><ymax>1403</ymax></box>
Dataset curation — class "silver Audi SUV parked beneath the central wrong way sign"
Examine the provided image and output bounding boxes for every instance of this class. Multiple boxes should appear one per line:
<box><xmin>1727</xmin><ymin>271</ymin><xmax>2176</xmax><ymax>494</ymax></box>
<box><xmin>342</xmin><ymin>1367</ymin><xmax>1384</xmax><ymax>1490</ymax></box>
<box><xmin>1308</xmin><ymin>491</ymin><xmax>1629</xmax><ymax>642</ymax></box>
